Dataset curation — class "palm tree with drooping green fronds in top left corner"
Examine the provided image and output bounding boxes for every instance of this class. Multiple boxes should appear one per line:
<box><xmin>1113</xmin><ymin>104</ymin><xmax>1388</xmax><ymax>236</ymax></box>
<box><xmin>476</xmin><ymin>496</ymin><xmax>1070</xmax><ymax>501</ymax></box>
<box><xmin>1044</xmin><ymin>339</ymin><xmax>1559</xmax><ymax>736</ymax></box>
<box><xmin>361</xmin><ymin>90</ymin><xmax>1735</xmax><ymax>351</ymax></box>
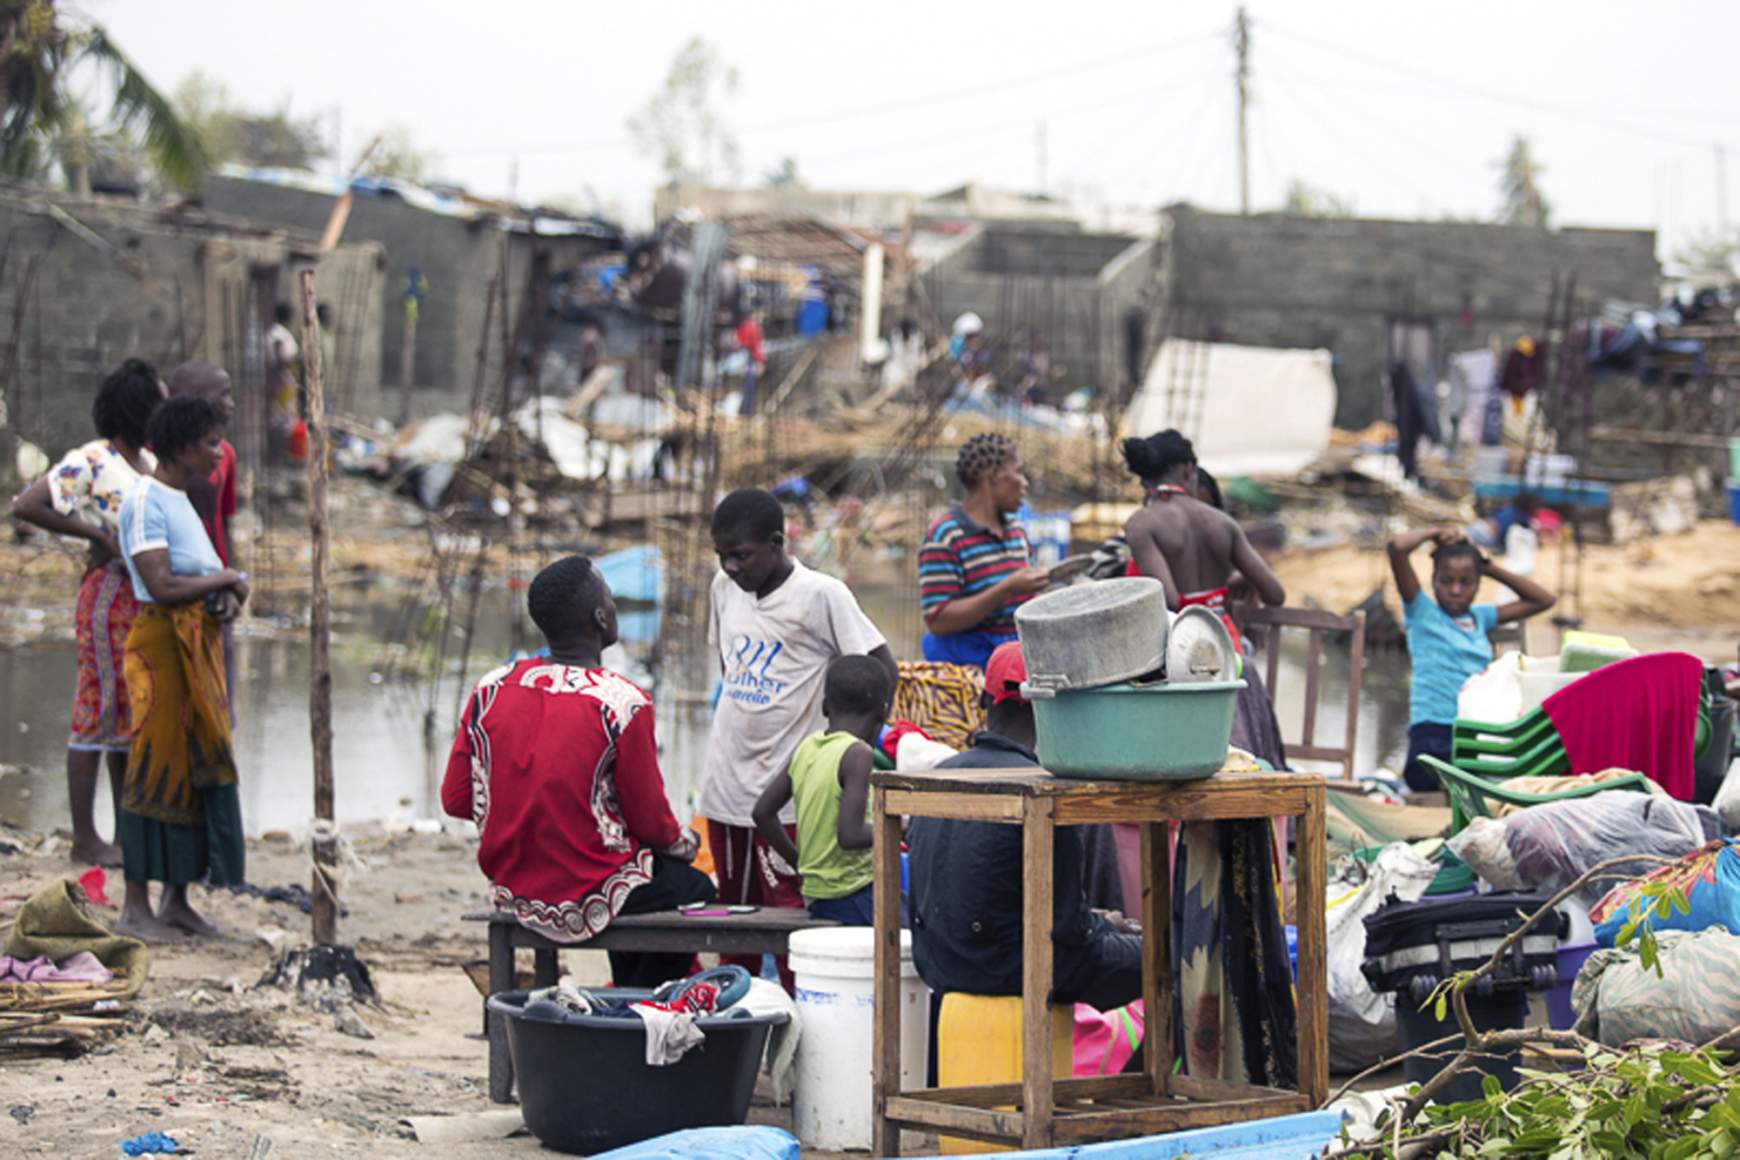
<box><xmin>0</xmin><ymin>0</ymin><xmax>205</xmax><ymax>190</ymax></box>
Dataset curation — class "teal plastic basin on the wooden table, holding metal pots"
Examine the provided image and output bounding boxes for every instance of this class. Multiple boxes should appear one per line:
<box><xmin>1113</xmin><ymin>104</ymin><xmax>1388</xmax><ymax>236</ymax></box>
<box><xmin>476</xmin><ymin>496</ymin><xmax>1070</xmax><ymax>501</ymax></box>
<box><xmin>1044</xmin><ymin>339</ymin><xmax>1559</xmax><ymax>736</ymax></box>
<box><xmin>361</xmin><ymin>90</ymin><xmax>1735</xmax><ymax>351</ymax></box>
<box><xmin>1030</xmin><ymin>680</ymin><xmax>1244</xmax><ymax>781</ymax></box>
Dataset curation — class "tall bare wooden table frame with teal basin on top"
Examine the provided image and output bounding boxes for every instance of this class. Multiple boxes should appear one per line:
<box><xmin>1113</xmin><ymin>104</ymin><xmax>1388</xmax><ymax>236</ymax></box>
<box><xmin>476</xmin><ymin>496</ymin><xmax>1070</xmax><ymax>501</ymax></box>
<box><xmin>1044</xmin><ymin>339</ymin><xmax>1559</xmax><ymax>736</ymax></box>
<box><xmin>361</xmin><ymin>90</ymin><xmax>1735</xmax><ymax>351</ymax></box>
<box><xmin>870</xmin><ymin>769</ymin><xmax>1329</xmax><ymax>1157</ymax></box>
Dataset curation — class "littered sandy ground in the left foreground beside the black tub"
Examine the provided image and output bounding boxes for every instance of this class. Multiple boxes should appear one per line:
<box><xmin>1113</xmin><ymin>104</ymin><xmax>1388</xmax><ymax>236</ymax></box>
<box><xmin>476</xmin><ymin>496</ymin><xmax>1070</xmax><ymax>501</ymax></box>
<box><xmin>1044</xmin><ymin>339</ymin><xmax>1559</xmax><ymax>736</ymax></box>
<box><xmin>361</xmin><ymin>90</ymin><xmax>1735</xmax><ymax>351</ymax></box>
<box><xmin>0</xmin><ymin>833</ymin><xmax>863</xmax><ymax>1160</ymax></box>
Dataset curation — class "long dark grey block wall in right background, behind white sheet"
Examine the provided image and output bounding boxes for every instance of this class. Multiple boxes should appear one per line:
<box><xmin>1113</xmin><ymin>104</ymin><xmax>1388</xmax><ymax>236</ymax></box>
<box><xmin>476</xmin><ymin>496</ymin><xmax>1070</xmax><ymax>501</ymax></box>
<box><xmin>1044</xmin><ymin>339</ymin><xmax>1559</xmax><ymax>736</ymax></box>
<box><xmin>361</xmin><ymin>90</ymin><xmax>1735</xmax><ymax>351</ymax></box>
<box><xmin>1162</xmin><ymin>207</ymin><xmax>1660</xmax><ymax>428</ymax></box>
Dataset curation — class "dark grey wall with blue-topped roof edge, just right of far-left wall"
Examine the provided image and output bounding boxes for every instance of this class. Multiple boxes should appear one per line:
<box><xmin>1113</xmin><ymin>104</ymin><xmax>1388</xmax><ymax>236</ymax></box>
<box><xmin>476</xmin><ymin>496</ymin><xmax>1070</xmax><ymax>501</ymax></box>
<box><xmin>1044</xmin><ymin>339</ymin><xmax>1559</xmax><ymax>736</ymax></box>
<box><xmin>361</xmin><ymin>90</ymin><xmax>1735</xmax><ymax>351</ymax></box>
<box><xmin>205</xmin><ymin>177</ymin><xmax>612</xmax><ymax>414</ymax></box>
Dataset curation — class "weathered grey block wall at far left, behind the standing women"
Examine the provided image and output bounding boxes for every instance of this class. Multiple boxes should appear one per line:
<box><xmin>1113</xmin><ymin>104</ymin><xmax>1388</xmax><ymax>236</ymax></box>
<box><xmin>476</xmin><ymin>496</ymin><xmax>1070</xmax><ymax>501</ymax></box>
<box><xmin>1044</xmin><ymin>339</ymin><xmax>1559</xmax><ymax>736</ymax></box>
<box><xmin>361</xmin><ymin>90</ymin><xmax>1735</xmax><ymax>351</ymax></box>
<box><xmin>0</xmin><ymin>191</ymin><xmax>381</xmax><ymax>457</ymax></box>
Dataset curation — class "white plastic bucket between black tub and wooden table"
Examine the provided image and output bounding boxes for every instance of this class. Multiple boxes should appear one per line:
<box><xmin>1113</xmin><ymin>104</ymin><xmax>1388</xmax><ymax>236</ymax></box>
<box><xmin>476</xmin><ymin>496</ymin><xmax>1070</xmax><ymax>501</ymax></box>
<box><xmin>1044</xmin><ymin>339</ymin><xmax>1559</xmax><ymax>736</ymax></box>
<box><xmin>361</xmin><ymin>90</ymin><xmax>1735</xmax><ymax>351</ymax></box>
<box><xmin>790</xmin><ymin>927</ymin><xmax>931</xmax><ymax>1151</ymax></box>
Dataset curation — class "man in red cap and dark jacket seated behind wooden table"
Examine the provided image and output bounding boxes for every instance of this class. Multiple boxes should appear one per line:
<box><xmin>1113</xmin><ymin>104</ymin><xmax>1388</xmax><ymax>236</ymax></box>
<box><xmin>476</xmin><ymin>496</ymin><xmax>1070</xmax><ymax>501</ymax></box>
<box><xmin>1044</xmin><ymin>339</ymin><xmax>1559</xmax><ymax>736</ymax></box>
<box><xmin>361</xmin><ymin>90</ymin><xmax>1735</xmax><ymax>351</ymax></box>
<box><xmin>907</xmin><ymin>642</ymin><xmax>1141</xmax><ymax>1010</ymax></box>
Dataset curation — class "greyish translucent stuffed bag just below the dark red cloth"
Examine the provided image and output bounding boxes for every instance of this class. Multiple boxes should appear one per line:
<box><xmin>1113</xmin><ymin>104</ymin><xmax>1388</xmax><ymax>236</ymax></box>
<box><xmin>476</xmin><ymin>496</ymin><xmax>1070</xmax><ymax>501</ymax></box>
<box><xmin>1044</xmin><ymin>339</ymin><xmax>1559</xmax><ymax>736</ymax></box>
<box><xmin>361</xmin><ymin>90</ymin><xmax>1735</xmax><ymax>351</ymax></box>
<box><xmin>1449</xmin><ymin>790</ymin><xmax>1721</xmax><ymax>904</ymax></box>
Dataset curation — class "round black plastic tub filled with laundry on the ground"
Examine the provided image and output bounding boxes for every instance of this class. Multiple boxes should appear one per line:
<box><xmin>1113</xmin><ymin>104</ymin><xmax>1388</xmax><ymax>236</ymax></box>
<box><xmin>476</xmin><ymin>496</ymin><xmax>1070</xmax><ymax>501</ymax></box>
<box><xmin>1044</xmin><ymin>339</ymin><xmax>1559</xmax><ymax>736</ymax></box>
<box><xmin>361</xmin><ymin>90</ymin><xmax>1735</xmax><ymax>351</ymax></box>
<box><xmin>489</xmin><ymin>988</ymin><xmax>783</xmax><ymax>1155</ymax></box>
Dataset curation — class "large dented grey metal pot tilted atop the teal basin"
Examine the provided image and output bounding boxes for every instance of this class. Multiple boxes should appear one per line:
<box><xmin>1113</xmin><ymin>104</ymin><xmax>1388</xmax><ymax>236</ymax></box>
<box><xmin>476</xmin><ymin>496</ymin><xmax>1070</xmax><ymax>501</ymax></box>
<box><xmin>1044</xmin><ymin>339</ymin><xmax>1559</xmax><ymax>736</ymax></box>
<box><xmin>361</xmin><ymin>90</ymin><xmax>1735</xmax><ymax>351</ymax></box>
<box><xmin>1014</xmin><ymin>576</ymin><xmax>1169</xmax><ymax>690</ymax></box>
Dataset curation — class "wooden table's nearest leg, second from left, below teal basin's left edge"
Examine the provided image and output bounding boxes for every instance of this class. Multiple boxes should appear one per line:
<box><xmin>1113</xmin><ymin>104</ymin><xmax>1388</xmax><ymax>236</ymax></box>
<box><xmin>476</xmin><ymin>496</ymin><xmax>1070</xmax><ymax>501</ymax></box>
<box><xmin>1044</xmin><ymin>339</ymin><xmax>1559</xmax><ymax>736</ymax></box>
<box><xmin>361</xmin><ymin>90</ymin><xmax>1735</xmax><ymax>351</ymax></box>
<box><xmin>1021</xmin><ymin>798</ymin><xmax>1056</xmax><ymax>1148</ymax></box>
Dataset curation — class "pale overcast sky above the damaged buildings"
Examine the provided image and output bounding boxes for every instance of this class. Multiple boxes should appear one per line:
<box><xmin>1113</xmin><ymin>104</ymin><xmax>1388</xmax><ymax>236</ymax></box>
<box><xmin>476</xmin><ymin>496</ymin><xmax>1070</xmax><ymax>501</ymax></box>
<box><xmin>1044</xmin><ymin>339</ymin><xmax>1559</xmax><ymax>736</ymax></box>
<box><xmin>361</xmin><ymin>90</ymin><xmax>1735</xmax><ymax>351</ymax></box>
<box><xmin>82</xmin><ymin>0</ymin><xmax>1740</xmax><ymax>256</ymax></box>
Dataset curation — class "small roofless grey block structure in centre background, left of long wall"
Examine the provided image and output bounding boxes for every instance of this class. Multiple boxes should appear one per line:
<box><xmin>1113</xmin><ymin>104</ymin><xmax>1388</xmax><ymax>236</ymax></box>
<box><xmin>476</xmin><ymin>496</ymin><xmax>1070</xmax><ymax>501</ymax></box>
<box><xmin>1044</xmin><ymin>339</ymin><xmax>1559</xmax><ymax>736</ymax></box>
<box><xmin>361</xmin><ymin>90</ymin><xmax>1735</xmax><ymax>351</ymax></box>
<box><xmin>926</xmin><ymin>228</ymin><xmax>1157</xmax><ymax>386</ymax></box>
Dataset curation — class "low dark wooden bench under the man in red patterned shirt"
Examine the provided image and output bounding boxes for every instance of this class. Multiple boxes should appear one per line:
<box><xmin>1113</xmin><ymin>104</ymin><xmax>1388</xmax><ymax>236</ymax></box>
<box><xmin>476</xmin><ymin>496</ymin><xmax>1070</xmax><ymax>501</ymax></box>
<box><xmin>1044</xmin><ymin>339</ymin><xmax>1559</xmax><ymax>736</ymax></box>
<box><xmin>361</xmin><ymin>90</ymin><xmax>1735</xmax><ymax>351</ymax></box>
<box><xmin>465</xmin><ymin>906</ymin><xmax>839</xmax><ymax>1104</ymax></box>
